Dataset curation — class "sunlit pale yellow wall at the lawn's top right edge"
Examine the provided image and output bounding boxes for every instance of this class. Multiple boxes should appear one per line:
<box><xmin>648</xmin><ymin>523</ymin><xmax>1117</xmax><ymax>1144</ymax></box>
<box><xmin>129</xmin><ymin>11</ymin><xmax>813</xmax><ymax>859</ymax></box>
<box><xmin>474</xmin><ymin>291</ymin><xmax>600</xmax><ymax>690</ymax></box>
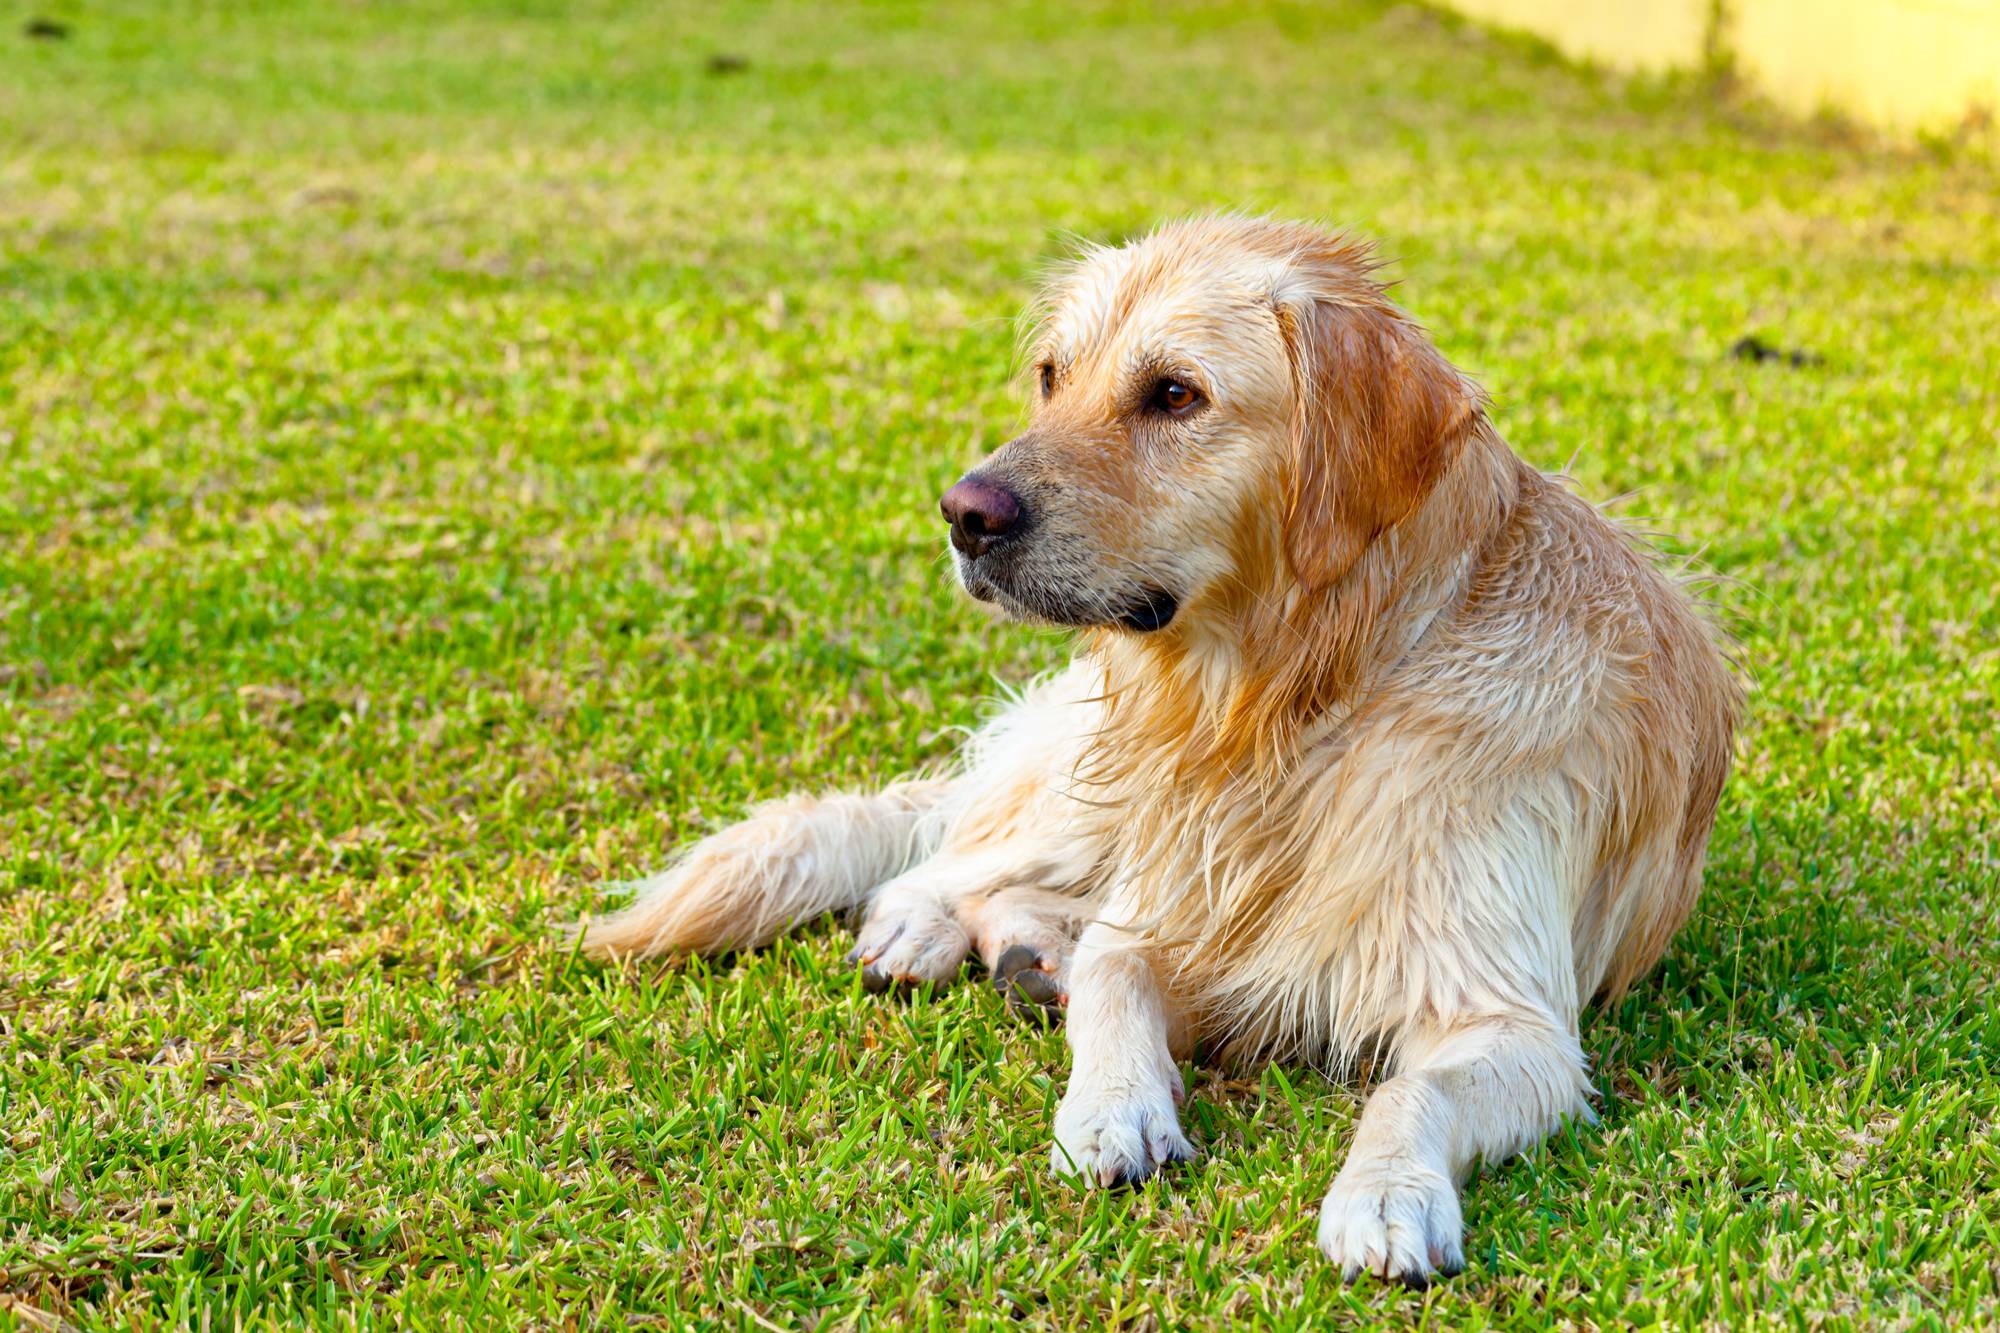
<box><xmin>1448</xmin><ymin>0</ymin><xmax>2000</xmax><ymax>130</ymax></box>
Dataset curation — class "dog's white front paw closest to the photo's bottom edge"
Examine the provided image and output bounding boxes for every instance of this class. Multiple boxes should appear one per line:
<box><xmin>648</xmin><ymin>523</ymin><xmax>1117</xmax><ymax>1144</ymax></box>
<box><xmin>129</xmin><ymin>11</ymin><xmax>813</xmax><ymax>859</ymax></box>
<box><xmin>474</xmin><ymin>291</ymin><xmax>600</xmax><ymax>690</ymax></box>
<box><xmin>1320</xmin><ymin>1157</ymin><xmax>1466</xmax><ymax>1287</ymax></box>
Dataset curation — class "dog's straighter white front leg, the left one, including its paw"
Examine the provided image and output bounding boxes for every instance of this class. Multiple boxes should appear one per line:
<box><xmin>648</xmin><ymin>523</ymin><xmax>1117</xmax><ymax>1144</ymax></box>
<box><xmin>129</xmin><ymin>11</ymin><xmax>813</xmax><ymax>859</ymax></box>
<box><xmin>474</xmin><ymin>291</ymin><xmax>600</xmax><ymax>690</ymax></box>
<box><xmin>1052</xmin><ymin>921</ymin><xmax>1194</xmax><ymax>1185</ymax></box>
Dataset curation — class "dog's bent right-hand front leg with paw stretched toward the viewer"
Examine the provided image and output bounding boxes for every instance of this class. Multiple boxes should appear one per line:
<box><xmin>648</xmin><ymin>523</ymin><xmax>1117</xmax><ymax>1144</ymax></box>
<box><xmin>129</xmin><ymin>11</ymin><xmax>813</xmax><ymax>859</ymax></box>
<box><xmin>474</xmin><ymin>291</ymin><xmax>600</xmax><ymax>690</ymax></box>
<box><xmin>1320</xmin><ymin>1009</ymin><xmax>1590</xmax><ymax>1287</ymax></box>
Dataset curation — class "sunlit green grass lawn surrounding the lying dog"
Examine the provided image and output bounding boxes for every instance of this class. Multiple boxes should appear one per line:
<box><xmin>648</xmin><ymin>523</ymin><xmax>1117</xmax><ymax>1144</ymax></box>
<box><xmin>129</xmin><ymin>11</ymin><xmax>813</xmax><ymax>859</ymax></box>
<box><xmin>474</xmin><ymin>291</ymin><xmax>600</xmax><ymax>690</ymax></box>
<box><xmin>0</xmin><ymin>0</ymin><xmax>2000</xmax><ymax>1329</ymax></box>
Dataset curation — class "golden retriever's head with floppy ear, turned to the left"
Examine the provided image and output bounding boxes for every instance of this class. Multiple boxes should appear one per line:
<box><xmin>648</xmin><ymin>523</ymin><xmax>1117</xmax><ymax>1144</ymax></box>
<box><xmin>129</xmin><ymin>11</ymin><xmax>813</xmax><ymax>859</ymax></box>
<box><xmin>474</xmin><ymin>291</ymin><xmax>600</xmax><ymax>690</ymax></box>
<box><xmin>942</xmin><ymin>218</ymin><xmax>1480</xmax><ymax>632</ymax></box>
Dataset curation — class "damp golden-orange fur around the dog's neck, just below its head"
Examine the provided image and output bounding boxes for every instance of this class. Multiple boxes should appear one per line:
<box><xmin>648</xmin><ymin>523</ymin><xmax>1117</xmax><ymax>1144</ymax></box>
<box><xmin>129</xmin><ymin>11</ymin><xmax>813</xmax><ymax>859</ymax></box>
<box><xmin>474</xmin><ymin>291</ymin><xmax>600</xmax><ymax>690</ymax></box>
<box><xmin>1086</xmin><ymin>420</ymin><xmax>1528</xmax><ymax>803</ymax></box>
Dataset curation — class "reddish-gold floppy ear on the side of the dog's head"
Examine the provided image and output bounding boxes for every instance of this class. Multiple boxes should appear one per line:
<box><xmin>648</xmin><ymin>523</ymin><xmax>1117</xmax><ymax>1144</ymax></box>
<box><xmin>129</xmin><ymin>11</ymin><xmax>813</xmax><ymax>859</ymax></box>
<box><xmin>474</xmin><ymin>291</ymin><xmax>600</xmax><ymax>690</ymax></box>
<box><xmin>1278</xmin><ymin>300</ymin><xmax>1480</xmax><ymax>588</ymax></box>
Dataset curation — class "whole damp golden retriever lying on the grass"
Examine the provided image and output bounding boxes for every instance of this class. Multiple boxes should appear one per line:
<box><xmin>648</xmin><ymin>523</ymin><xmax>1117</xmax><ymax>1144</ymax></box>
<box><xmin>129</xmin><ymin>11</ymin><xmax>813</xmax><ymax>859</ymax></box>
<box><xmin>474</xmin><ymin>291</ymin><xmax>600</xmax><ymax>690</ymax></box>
<box><xmin>584</xmin><ymin>216</ymin><xmax>1740</xmax><ymax>1285</ymax></box>
